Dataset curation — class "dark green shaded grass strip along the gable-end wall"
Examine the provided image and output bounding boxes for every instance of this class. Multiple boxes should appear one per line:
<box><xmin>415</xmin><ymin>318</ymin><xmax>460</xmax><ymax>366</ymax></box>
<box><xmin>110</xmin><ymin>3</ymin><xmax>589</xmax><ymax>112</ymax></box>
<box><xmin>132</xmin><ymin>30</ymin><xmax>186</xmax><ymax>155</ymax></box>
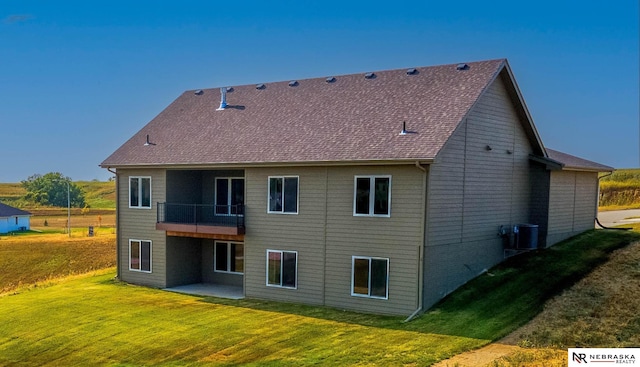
<box><xmin>412</xmin><ymin>230</ymin><xmax>640</xmax><ymax>340</ymax></box>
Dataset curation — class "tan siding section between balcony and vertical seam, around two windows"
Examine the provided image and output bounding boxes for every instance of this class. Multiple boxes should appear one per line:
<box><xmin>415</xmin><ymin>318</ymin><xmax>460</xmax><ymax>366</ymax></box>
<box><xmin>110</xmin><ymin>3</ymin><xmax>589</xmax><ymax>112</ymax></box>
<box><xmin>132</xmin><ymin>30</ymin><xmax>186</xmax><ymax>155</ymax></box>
<box><xmin>245</xmin><ymin>167</ymin><xmax>327</xmax><ymax>304</ymax></box>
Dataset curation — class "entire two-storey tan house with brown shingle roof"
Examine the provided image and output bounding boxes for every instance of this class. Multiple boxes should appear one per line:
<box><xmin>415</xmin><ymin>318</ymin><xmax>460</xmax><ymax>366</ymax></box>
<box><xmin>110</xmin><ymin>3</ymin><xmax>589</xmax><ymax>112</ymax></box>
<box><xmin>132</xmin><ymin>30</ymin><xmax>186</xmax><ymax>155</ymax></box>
<box><xmin>101</xmin><ymin>59</ymin><xmax>613</xmax><ymax>315</ymax></box>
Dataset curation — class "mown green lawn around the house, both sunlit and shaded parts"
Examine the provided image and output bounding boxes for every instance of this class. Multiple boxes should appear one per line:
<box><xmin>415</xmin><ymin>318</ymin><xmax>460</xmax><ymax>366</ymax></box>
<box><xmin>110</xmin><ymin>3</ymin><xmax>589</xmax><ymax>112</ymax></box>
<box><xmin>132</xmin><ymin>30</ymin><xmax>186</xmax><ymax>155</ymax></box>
<box><xmin>0</xmin><ymin>230</ymin><xmax>640</xmax><ymax>366</ymax></box>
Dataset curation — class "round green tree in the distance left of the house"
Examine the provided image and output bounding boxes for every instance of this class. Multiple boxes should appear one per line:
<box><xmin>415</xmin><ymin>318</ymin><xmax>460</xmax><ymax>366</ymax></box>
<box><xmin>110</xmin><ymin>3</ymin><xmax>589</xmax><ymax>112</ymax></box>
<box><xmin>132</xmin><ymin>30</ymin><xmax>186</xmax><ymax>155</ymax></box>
<box><xmin>20</xmin><ymin>172</ymin><xmax>85</xmax><ymax>208</ymax></box>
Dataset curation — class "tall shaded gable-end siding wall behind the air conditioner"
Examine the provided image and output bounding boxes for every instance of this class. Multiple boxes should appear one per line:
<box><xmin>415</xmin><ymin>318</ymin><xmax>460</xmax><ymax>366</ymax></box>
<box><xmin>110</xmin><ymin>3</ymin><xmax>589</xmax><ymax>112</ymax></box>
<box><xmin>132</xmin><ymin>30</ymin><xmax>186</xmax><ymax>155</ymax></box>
<box><xmin>424</xmin><ymin>78</ymin><xmax>533</xmax><ymax>307</ymax></box>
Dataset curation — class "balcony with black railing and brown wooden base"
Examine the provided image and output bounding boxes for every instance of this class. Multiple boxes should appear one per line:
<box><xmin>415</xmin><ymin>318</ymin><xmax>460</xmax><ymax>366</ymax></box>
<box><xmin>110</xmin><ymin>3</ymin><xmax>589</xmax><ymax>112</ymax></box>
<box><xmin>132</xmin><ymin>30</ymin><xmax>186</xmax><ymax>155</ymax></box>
<box><xmin>156</xmin><ymin>203</ymin><xmax>245</xmax><ymax>240</ymax></box>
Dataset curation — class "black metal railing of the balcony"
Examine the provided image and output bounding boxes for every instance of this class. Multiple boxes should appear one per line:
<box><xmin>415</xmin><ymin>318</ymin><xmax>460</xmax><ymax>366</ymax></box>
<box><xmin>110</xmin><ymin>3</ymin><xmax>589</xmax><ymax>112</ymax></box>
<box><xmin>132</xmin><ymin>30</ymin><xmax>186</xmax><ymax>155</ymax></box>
<box><xmin>158</xmin><ymin>203</ymin><xmax>244</xmax><ymax>232</ymax></box>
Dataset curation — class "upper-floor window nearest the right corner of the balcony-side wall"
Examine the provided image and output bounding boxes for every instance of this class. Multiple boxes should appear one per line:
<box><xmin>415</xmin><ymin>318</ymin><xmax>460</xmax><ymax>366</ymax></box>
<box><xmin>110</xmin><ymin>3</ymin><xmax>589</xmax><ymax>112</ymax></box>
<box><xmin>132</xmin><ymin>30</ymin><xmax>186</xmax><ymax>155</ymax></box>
<box><xmin>353</xmin><ymin>176</ymin><xmax>391</xmax><ymax>217</ymax></box>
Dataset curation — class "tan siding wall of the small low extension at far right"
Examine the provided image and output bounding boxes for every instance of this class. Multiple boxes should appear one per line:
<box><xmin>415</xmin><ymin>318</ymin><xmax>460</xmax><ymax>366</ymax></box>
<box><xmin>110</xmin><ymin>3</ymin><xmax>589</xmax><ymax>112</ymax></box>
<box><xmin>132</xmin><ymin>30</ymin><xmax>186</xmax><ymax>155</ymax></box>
<box><xmin>547</xmin><ymin>171</ymin><xmax>598</xmax><ymax>246</ymax></box>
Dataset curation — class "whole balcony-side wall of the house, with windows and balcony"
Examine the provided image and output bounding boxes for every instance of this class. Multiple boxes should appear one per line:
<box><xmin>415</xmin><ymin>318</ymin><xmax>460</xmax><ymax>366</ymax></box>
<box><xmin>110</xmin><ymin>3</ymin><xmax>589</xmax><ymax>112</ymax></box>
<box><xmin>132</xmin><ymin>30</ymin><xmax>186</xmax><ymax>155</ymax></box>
<box><xmin>118</xmin><ymin>165</ymin><xmax>426</xmax><ymax>314</ymax></box>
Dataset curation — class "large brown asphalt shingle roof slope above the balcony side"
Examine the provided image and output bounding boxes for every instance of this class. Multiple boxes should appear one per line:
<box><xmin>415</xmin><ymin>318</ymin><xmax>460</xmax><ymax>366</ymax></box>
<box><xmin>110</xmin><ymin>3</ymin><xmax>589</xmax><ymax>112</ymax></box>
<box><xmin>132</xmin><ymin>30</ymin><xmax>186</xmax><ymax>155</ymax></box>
<box><xmin>101</xmin><ymin>59</ymin><xmax>506</xmax><ymax>167</ymax></box>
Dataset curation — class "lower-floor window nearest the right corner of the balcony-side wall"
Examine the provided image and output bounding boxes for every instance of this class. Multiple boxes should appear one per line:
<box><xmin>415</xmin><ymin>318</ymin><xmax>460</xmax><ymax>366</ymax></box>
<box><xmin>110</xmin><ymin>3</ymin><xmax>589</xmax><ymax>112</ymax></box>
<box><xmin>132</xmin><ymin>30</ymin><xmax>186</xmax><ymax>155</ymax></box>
<box><xmin>351</xmin><ymin>256</ymin><xmax>389</xmax><ymax>299</ymax></box>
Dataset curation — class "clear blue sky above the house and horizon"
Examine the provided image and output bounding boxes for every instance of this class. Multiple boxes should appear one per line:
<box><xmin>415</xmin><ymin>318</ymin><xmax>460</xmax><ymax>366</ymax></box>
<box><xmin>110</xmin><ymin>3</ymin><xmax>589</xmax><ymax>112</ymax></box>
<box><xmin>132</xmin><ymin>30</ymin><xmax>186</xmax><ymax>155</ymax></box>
<box><xmin>0</xmin><ymin>0</ymin><xmax>640</xmax><ymax>182</ymax></box>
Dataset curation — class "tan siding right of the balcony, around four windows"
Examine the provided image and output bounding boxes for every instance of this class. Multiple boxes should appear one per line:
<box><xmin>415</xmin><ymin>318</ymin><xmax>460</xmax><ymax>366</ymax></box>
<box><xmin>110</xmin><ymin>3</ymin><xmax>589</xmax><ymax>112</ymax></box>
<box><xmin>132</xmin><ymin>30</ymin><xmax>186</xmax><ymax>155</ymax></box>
<box><xmin>245</xmin><ymin>166</ymin><xmax>424</xmax><ymax>315</ymax></box>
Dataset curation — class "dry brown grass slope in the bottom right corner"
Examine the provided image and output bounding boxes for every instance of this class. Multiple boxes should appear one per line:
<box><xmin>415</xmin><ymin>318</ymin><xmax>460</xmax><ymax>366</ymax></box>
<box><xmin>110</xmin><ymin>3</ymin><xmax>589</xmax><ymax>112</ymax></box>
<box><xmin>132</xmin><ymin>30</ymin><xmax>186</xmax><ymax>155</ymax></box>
<box><xmin>504</xmin><ymin>237</ymin><xmax>640</xmax><ymax>348</ymax></box>
